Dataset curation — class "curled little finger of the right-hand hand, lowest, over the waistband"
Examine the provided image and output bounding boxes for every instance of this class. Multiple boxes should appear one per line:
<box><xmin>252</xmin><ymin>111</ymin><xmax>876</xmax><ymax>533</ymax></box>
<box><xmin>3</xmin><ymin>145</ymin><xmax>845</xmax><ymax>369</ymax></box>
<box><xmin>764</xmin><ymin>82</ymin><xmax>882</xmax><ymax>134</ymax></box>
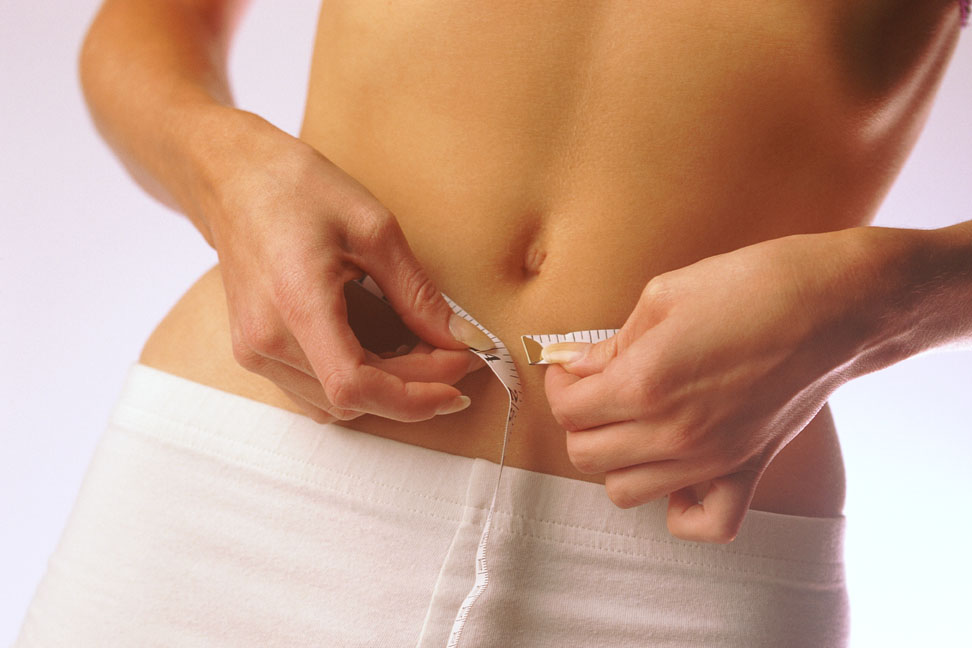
<box><xmin>668</xmin><ymin>470</ymin><xmax>759</xmax><ymax>544</ymax></box>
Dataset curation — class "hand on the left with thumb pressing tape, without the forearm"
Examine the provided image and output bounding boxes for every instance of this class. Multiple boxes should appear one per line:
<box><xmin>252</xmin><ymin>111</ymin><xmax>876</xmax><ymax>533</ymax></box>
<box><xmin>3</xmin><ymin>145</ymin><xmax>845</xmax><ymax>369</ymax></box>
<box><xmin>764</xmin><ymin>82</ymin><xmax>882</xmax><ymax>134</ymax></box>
<box><xmin>193</xmin><ymin>111</ymin><xmax>492</xmax><ymax>423</ymax></box>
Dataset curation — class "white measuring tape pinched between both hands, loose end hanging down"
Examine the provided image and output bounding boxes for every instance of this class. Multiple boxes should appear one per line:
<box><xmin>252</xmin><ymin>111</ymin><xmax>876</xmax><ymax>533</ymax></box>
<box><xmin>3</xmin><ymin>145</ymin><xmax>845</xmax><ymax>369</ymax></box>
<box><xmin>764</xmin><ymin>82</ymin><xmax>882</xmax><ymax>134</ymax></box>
<box><xmin>357</xmin><ymin>275</ymin><xmax>618</xmax><ymax>648</ymax></box>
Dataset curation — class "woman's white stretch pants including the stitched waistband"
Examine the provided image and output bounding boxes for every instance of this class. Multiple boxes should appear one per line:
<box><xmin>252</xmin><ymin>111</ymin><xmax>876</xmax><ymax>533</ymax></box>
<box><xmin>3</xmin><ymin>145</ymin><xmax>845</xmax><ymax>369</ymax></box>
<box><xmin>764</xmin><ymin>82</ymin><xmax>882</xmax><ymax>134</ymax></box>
<box><xmin>15</xmin><ymin>364</ymin><xmax>848</xmax><ymax>648</ymax></box>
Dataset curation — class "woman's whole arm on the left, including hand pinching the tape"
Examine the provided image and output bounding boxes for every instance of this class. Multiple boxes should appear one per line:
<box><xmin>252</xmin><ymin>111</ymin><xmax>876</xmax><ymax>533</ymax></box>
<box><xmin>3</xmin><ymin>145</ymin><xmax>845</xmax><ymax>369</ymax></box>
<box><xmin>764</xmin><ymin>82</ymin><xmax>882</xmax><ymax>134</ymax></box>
<box><xmin>80</xmin><ymin>0</ymin><xmax>490</xmax><ymax>422</ymax></box>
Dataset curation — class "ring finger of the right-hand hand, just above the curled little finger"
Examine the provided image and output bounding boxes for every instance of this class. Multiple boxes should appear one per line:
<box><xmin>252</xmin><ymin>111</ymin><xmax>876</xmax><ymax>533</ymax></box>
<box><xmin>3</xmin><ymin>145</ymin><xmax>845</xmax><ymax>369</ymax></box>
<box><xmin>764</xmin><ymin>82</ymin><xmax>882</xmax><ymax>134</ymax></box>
<box><xmin>604</xmin><ymin>459</ymin><xmax>713</xmax><ymax>508</ymax></box>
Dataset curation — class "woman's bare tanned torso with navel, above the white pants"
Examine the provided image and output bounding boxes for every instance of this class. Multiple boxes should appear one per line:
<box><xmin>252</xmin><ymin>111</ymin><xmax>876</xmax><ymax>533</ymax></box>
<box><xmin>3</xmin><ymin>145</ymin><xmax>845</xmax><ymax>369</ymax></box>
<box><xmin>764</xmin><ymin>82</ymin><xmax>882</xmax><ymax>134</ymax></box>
<box><xmin>140</xmin><ymin>0</ymin><xmax>958</xmax><ymax>516</ymax></box>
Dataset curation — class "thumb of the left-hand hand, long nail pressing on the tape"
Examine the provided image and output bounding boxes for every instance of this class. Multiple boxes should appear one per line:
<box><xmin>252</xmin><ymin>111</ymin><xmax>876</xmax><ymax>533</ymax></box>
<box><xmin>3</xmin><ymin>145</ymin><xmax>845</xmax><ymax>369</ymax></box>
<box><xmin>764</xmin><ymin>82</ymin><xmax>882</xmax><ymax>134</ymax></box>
<box><xmin>351</xmin><ymin>213</ymin><xmax>493</xmax><ymax>350</ymax></box>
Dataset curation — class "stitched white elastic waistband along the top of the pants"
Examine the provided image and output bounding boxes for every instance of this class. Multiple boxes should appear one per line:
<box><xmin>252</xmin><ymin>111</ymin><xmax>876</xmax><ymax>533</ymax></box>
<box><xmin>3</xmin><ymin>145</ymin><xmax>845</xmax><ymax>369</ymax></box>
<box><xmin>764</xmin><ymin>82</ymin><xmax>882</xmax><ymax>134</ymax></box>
<box><xmin>112</xmin><ymin>363</ymin><xmax>844</xmax><ymax>582</ymax></box>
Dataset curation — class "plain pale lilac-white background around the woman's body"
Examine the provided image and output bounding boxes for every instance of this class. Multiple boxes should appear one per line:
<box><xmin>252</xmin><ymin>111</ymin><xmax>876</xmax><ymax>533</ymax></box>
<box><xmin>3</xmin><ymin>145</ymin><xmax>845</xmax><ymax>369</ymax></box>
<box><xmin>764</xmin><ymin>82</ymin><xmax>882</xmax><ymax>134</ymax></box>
<box><xmin>0</xmin><ymin>0</ymin><xmax>972</xmax><ymax>648</ymax></box>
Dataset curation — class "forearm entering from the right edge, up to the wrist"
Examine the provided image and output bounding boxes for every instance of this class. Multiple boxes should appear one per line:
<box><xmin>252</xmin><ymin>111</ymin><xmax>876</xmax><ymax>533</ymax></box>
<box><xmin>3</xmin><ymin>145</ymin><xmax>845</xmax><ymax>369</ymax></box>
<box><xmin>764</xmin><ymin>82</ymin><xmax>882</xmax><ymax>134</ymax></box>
<box><xmin>847</xmin><ymin>221</ymin><xmax>972</xmax><ymax>375</ymax></box>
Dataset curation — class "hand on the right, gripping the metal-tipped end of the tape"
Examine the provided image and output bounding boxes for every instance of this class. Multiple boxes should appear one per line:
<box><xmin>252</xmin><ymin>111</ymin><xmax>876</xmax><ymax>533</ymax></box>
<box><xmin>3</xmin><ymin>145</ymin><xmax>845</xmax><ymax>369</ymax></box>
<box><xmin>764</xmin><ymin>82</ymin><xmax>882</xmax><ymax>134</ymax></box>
<box><xmin>544</xmin><ymin>228</ymin><xmax>880</xmax><ymax>543</ymax></box>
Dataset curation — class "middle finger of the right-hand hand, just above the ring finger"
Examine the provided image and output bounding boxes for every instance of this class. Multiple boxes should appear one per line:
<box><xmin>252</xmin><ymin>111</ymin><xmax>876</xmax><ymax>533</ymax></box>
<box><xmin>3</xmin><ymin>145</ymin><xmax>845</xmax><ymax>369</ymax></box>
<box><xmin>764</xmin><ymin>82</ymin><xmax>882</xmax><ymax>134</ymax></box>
<box><xmin>567</xmin><ymin>421</ymin><xmax>679</xmax><ymax>474</ymax></box>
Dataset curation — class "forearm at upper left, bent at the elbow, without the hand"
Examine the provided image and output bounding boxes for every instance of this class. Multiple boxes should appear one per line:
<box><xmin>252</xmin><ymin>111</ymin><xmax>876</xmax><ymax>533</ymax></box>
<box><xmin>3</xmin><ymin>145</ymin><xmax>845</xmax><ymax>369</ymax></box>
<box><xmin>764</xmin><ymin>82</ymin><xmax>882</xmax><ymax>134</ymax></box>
<box><xmin>79</xmin><ymin>0</ymin><xmax>251</xmax><ymax>244</ymax></box>
